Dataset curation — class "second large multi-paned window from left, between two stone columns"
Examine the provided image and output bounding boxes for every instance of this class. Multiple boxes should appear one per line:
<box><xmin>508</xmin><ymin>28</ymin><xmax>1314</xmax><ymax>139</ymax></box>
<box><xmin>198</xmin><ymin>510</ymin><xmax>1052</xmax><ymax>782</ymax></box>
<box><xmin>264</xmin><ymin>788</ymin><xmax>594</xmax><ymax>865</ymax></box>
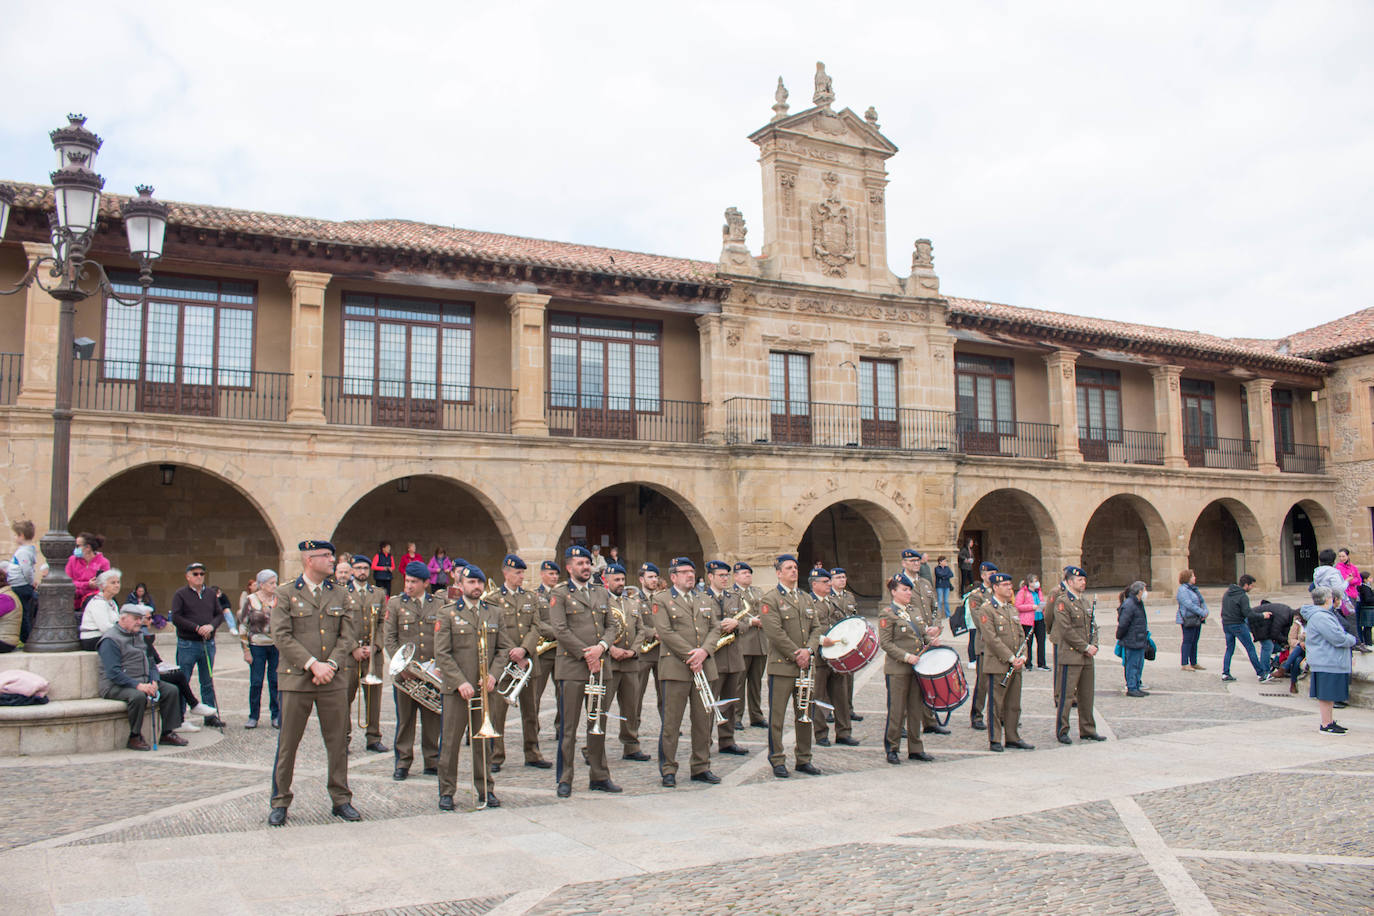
<box><xmin>344</xmin><ymin>293</ymin><xmax>473</xmax><ymax>401</ymax></box>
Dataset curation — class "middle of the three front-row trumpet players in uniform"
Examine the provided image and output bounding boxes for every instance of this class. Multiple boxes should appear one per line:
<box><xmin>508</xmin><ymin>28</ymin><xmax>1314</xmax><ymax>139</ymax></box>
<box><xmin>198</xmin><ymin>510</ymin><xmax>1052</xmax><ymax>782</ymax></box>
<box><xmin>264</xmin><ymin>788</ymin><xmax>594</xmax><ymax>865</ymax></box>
<box><xmin>649</xmin><ymin>556</ymin><xmax>720</xmax><ymax>788</ymax></box>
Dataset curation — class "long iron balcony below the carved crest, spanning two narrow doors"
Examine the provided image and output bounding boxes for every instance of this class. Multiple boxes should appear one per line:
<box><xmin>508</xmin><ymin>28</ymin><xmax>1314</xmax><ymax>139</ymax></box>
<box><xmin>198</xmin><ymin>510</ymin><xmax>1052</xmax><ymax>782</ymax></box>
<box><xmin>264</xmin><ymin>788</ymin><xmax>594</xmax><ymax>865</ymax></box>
<box><xmin>725</xmin><ymin>398</ymin><xmax>958</xmax><ymax>452</ymax></box>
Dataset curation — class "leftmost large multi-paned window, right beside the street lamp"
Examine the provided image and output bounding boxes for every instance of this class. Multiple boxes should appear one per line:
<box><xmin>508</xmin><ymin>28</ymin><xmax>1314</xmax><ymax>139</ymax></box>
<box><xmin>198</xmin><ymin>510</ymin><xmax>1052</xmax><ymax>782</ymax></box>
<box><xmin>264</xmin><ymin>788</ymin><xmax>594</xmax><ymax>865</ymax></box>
<box><xmin>103</xmin><ymin>271</ymin><xmax>257</xmax><ymax>387</ymax></box>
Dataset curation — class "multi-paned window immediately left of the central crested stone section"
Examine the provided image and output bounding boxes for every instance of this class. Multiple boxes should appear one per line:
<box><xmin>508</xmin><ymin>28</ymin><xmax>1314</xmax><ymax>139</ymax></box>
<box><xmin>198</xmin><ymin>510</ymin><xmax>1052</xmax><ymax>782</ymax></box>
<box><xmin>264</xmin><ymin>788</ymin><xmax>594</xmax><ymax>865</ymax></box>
<box><xmin>548</xmin><ymin>312</ymin><xmax>662</xmax><ymax>413</ymax></box>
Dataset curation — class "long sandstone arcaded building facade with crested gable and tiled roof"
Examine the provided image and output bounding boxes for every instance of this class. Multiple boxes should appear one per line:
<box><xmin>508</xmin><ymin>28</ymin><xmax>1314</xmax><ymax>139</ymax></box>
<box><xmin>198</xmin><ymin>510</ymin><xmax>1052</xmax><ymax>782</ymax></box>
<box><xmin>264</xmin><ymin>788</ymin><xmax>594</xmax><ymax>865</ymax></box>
<box><xmin>0</xmin><ymin>70</ymin><xmax>1352</xmax><ymax>600</ymax></box>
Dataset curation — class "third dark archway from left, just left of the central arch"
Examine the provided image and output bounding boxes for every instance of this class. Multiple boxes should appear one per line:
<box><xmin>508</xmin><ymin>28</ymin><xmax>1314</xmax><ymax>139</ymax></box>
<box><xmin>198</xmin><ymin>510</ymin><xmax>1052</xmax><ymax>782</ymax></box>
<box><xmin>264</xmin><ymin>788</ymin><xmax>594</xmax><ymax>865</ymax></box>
<box><xmin>556</xmin><ymin>483</ymin><xmax>714</xmax><ymax>581</ymax></box>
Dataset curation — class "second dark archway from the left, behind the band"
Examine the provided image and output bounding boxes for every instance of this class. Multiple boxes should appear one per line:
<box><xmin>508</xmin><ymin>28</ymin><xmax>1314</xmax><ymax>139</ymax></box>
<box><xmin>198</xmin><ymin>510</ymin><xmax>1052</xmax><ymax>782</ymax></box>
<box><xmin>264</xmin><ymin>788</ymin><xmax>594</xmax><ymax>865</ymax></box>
<box><xmin>333</xmin><ymin>475</ymin><xmax>510</xmax><ymax>592</ymax></box>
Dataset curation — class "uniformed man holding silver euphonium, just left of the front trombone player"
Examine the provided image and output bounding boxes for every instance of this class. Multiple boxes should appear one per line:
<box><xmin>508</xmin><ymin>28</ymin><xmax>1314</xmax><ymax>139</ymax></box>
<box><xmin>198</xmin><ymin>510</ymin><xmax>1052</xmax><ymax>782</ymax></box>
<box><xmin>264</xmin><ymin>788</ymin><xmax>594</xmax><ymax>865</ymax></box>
<box><xmin>382</xmin><ymin>560</ymin><xmax>444</xmax><ymax>781</ymax></box>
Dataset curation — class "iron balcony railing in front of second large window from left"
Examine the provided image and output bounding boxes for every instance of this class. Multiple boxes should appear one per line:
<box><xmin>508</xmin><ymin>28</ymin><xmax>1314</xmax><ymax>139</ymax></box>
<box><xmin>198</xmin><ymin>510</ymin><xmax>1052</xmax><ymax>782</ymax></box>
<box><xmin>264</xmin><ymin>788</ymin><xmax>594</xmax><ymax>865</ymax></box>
<box><xmin>323</xmin><ymin>375</ymin><xmax>515</xmax><ymax>433</ymax></box>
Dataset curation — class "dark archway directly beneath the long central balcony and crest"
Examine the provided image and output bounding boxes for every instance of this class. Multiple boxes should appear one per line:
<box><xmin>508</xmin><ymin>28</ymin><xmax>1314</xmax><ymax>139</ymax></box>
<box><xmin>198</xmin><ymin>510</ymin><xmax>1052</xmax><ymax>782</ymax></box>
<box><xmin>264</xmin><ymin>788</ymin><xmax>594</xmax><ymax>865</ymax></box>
<box><xmin>797</xmin><ymin>500</ymin><xmax>906</xmax><ymax>602</ymax></box>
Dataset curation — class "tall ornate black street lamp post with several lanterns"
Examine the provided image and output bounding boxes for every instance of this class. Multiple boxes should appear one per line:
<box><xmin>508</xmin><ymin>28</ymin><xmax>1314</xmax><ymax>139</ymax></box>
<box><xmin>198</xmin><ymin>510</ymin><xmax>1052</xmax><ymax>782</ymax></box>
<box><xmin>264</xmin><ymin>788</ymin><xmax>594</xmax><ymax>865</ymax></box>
<box><xmin>0</xmin><ymin>114</ymin><xmax>168</xmax><ymax>652</ymax></box>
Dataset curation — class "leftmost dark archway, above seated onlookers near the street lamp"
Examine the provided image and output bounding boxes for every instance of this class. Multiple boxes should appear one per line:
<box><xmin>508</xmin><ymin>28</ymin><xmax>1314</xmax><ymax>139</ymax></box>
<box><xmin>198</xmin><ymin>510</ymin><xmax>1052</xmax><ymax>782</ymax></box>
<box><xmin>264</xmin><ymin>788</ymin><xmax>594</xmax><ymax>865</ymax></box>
<box><xmin>70</xmin><ymin>464</ymin><xmax>282</xmax><ymax>612</ymax></box>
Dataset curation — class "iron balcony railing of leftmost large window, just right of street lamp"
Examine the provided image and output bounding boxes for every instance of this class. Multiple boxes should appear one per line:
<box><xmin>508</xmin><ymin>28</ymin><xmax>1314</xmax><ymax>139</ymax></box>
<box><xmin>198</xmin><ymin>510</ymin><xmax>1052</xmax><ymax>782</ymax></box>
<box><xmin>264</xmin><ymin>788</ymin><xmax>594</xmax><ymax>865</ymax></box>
<box><xmin>71</xmin><ymin>360</ymin><xmax>291</xmax><ymax>423</ymax></box>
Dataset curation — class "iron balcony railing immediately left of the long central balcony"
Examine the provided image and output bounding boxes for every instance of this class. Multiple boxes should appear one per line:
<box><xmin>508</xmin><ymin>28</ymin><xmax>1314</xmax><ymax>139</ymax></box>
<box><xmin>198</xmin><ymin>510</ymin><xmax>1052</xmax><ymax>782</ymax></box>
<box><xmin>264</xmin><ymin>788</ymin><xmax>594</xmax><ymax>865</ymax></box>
<box><xmin>544</xmin><ymin>391</ymin><xmax>706</xmax><ymax>442</ymax></box>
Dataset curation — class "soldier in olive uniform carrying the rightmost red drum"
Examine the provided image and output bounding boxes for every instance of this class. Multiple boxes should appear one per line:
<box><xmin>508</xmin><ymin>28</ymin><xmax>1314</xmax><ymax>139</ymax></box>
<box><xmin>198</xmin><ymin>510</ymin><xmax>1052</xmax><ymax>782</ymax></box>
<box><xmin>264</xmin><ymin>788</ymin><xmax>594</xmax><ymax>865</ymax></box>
<box><xmin>878</xmin><ymin>573</ymin><xmax>940</xmax><ymax>764</ymax></box>
